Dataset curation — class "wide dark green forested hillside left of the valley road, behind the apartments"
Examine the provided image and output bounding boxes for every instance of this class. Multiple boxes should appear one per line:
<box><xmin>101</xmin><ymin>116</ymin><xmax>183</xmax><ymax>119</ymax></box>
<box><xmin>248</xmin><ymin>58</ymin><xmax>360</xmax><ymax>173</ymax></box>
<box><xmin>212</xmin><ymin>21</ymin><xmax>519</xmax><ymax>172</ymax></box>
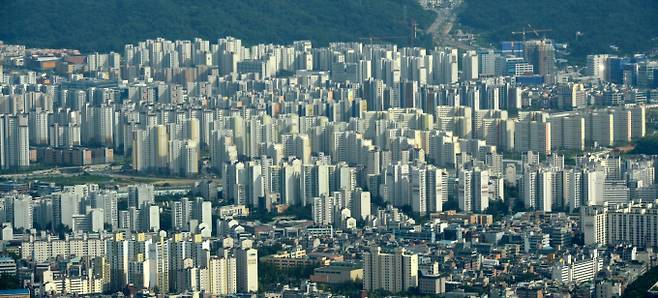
<box><xmin>0</xmin><ymin>0</ymin><xmax>434</xmax><ymax>51</ymax></box>
